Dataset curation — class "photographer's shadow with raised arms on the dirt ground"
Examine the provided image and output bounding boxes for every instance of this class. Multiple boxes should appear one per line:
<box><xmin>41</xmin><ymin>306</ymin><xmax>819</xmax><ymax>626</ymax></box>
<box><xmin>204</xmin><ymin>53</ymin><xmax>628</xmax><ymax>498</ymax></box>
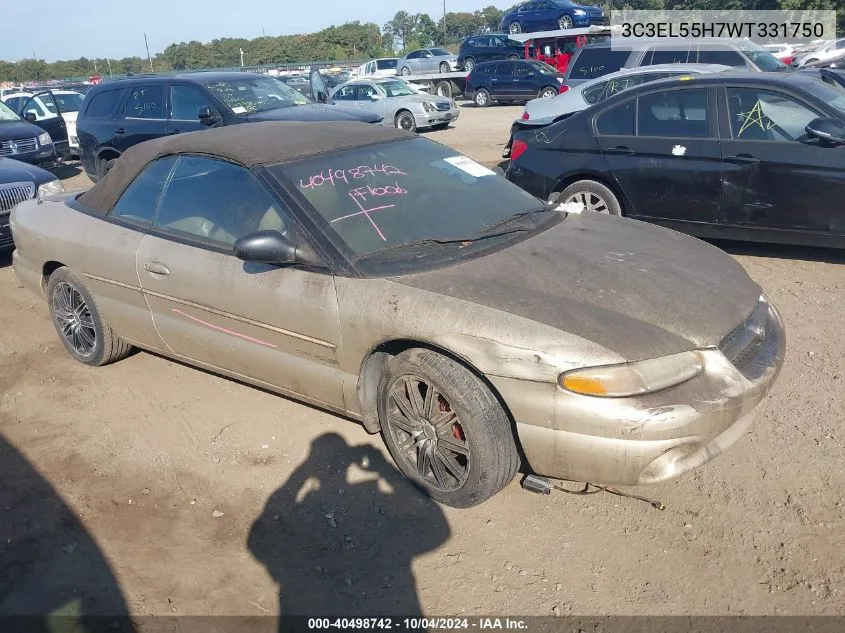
<box><xmin>248</xmin><ymin>433</ymin><xmax>449</xmax><ymax>629</ymax></box>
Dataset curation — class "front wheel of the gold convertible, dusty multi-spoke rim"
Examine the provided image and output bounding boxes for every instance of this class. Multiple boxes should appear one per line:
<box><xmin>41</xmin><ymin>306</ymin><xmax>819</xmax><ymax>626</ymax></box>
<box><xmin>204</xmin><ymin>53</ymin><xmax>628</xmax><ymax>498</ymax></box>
<box><xmin>378</xmin><ymin>349</ymin><xmax>519</xmax><ymax>508</ymax></box>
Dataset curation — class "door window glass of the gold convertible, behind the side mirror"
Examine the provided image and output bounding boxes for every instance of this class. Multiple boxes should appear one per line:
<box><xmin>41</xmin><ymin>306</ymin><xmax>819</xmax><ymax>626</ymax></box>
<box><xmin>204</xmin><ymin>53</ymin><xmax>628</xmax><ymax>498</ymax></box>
<box><xmin>154</xmin><ymin>156</ymin><xmax>290</xmax><ymax>246</ymax></box>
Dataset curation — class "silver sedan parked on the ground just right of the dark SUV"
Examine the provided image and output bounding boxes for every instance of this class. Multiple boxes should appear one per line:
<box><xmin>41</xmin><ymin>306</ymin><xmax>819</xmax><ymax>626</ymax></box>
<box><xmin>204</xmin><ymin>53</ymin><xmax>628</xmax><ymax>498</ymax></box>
<box><xmin>332</xmin><ymin>77</ymin><xmax>460</xmax><ymax>132</ymax></box>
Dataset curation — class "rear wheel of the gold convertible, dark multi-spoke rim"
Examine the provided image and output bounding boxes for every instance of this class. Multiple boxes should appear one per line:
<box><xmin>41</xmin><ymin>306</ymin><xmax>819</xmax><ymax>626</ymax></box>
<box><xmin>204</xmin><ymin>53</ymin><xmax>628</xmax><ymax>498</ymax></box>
<box><xmin>47</xmin><ymin>267</ymin><xmax>132</xmax><ymax>367</ymax></box>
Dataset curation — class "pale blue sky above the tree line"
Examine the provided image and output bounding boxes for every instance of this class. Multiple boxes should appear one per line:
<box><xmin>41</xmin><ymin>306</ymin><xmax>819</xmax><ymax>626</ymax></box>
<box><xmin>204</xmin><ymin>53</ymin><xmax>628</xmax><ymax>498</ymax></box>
<box><xmin>0</xmin><ymin>0</ymin><xmax>504</xmax><ymax>62</ymax></box>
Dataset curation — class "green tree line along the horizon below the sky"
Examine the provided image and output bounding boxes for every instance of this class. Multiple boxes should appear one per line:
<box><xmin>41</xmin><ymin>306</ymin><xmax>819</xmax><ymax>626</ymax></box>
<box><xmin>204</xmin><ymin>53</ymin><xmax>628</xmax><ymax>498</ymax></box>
<box><xmin>0</xmin><ymin>0</ymin><xmax>845</xmax><ymax>82</ymax></box>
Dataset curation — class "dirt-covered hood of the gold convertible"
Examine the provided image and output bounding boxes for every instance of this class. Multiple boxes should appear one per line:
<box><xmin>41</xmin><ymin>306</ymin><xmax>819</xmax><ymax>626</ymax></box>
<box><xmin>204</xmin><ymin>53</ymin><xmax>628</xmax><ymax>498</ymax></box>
<box><xmin>392</xmin><ymin>213</ymin><xmax>761</xmax><ymax>361</ymax></box>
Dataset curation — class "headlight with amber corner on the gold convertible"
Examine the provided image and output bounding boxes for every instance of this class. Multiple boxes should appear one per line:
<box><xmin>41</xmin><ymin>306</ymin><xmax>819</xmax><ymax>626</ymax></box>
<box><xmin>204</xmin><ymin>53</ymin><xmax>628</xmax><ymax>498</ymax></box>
<box><xmin>558</xmin><ymin>351</ymin><xmax>704</xmax><ymax>398</ymax></box>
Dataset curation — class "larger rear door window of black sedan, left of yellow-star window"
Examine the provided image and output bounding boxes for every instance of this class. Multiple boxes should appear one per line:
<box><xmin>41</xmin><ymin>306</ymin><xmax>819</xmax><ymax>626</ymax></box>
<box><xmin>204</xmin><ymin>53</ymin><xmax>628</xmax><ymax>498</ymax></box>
<box><xmin>637</xmin><ymin>88</ymin><xmax>707</xmax><ymax>138</ymax></box>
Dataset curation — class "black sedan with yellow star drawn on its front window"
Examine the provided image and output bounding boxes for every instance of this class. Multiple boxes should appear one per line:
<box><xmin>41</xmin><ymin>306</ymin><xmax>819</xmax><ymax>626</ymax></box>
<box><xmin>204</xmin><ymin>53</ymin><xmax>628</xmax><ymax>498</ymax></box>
<box><xmin>507</xmin><ymin>72</ymin><xmax>845</xmax><ymax>247</ymax></box>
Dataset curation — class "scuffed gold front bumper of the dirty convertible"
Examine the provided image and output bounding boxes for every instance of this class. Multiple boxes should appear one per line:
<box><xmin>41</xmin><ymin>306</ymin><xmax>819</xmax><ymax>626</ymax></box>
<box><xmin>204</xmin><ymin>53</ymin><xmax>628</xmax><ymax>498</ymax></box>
<box><xmin>490</xmin><ymin>301</ymin><xmax>786</xmax><ymax>485</ymax></box>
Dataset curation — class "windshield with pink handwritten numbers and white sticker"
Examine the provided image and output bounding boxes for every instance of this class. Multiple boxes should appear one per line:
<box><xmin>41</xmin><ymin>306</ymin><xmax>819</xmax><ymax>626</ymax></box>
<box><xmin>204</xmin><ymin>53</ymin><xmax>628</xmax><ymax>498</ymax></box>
<box><xmin>270</xmin><ymin>139</ymin><xmax>546</xmax><ymax>259</ymax></box>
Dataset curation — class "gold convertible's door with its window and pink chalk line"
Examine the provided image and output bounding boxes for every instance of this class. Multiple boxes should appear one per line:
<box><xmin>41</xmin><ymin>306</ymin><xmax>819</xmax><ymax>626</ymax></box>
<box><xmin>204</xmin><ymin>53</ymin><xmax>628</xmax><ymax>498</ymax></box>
<box><xmin>136</xmin><ymin>156</ymin><xmax>344</xmax><ymax>407</ymax></box>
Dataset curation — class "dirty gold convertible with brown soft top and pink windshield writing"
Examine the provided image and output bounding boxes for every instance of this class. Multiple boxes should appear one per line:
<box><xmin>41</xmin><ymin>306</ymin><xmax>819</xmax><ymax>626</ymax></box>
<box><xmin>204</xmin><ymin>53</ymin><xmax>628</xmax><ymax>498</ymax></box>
<box><xmin>11</xmin><ymin>122</ymin><xmax>785</xmax><ymax>507</ymax></box>
